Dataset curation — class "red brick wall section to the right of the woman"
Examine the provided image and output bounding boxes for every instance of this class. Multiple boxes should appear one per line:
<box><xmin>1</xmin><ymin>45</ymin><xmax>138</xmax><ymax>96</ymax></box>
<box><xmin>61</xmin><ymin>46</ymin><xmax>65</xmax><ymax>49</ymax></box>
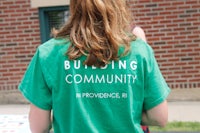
<box><xmin>130</xmin><ymin>0</ymin><xmax>200</xmax><ymax>88</ymax></box>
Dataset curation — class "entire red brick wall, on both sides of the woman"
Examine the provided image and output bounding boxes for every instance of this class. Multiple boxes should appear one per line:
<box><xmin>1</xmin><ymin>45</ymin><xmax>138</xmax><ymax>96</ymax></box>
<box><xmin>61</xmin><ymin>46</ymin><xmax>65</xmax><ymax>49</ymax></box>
<box><xmin>0</xmin><ymin>0</ymin><xmax>200</xmax><ymax>90</ymax></box>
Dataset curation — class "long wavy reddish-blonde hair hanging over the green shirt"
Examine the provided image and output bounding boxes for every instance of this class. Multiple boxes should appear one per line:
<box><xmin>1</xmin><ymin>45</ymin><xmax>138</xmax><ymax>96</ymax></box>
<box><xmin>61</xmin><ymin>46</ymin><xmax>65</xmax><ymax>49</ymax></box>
<box><xmin>55</xmin><ymin>0</ymin><xmax>135</xmax><ymax>67</ymax></box>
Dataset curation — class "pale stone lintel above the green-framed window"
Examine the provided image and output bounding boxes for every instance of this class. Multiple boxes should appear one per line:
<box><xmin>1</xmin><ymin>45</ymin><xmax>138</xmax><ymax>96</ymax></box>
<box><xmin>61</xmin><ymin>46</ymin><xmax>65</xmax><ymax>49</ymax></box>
<box><xmin>31</xmin><ymin>0</ymin><xmax>70</xmax><ymax>8</ymax></box>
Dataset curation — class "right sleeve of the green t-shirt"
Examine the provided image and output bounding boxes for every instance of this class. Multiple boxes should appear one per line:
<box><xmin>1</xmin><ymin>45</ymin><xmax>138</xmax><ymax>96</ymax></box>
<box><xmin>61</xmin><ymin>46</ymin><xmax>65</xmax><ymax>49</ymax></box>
<box><xmin>144</xmin><ymin>47</ymin><xmax>170</xmax><ymax>110</ymax></box>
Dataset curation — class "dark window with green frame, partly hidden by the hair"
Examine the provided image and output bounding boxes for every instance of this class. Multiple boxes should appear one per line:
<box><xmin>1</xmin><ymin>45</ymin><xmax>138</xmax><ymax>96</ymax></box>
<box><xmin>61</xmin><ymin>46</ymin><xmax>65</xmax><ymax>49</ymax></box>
<box><xmin>39</xmin><ymin>6</ymin><xmax>69</xmax><ymax>43</ymax></box>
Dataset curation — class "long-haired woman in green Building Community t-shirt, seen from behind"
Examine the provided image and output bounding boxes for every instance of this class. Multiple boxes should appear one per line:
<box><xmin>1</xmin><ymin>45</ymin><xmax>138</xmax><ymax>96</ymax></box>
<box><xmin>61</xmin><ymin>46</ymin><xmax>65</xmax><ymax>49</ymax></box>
<box><xmin>19</xmin><ymin>0</ymin><xmax>170</xmax><ymax>133</ymax></box>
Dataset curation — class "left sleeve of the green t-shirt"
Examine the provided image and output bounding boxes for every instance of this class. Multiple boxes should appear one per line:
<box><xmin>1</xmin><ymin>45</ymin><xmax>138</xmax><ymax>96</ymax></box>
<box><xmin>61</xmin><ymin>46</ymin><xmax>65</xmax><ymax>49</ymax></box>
<box><xmin>18</xmin><ymin>50</ymin><xmax>52</xmax><ymax>110</ymax></box>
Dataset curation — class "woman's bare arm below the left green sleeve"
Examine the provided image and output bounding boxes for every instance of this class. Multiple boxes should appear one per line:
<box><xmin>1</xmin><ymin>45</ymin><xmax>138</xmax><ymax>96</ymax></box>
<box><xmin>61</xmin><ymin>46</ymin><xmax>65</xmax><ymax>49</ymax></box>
<box><xmin>29</xmin><ymin>104</ymin><xmax>51</xmax><ymax>133</ymax></box>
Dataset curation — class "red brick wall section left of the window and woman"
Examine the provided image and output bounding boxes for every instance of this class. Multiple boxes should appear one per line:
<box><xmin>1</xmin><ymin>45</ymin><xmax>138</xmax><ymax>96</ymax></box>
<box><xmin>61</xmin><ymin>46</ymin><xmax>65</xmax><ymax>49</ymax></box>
<box><xmin>0</xmin><ymin>0</ymin><xmax>40</xmax><ymax>90</ymax></box>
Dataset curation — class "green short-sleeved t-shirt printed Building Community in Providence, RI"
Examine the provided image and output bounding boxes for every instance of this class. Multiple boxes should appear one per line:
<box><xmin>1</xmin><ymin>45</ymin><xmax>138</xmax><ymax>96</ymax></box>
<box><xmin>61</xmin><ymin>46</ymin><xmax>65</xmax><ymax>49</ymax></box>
<box><xmin>19</xmin><ymin>39</ymin><xmax>170</xmax><ymax>133</ymax></box>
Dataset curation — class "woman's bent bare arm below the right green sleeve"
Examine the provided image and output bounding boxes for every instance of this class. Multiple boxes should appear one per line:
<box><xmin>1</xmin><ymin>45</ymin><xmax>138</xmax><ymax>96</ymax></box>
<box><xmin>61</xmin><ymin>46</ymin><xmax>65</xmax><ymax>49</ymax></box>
<box><xmin>142</xmin><ymin>101</ymin><xmax>168</xmax><ymax>127</ymax></box>
